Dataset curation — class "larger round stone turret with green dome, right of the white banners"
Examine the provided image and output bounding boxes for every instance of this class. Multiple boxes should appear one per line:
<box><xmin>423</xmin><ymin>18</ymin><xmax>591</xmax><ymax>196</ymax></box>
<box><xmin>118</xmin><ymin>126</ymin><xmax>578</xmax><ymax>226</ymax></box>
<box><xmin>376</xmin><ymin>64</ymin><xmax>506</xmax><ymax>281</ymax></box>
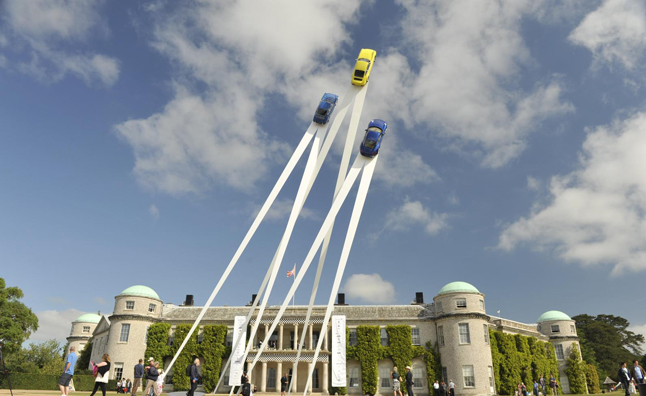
<box><xmin>433</xmin><ymin>282</ymin><xmax>494</xmax><ymax>395</ymax></box>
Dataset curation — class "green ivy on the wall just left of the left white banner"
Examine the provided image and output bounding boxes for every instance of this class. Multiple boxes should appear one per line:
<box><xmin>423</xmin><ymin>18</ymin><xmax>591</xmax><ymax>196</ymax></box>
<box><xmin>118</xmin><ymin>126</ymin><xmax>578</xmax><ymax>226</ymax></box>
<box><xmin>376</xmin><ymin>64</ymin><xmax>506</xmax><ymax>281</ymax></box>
<box><xmin>198</xmin><ymin>325</ymin><xmax>230</xmax><ymax>393</ymax></box>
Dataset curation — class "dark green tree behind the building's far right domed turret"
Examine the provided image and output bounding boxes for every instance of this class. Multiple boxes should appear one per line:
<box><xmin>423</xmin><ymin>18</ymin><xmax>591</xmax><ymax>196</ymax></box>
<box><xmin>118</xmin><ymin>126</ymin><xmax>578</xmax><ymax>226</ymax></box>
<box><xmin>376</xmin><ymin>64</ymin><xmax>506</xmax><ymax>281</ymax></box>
<box><xmin>572</xmin><ymin>315</ymin><xmax>644</xmax><ymax>380</ymax></box>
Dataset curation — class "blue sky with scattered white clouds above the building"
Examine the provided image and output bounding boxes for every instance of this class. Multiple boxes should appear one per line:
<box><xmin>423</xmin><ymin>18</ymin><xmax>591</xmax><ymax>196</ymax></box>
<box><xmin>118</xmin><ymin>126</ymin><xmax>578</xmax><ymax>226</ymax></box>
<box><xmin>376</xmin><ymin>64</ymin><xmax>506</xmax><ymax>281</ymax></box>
<box><xmin>0</xmin><ymin>0</ymin><xmax>646</xmax><ymax>341</ymax></box>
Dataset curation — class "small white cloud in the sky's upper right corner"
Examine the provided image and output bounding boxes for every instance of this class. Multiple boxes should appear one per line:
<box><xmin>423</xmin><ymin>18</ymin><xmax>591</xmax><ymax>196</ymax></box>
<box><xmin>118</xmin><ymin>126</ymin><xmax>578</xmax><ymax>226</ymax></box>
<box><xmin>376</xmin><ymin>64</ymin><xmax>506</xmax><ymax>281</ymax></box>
<box><xmin>569</xmin><ymin>0</ymin><xmax>646</xmax><ymax>70</ymax></box>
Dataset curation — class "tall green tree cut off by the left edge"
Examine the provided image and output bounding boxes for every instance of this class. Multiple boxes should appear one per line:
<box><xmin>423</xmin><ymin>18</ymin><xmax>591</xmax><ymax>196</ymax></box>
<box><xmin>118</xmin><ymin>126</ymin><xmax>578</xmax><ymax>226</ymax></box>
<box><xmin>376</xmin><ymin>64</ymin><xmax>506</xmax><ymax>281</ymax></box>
<box><xmin>0</xmin><ymin>278</ymin><xmax>38</xmax><ymax>355</ymax></box>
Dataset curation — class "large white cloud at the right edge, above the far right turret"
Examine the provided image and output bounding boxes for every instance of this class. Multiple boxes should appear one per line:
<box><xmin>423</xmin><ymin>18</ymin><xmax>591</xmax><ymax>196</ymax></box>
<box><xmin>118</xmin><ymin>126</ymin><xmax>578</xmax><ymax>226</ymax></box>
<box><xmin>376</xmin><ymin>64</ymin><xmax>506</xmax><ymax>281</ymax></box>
<box><xmin>499</xmin><ymin>112</ymin><xmax>646</xmax><ymax>274</ymax></box>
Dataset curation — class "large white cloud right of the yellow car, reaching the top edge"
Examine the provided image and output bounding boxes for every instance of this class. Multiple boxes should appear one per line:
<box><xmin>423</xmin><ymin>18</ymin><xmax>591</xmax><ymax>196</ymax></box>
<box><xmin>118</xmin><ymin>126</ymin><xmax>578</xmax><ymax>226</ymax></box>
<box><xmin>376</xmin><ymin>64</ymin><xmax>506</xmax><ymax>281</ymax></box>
<box><xmin>394</xmin><ymin>0</ymin><xmax>574</xmax><ymax>168</ymax></box>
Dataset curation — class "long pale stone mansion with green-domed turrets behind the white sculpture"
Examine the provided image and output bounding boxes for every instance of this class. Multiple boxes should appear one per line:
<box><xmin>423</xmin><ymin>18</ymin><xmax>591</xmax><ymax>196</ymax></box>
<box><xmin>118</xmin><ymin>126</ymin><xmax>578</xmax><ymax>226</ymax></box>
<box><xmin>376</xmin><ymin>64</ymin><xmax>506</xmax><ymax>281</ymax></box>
<box><xmin>68</xmin><ymin>282</ymin><xmax>578</xmax><ymax>395</ymax></box>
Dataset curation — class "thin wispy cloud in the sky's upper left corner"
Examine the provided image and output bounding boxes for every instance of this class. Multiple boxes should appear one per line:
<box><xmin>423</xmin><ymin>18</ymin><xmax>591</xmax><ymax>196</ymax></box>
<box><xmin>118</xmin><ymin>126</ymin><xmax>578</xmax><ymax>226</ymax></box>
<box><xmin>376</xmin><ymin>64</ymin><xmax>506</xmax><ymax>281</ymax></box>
<box><xmin>0</xmin><ymin>0</ymin><xmax>120</xmax><ymax>87</ymax></box>
